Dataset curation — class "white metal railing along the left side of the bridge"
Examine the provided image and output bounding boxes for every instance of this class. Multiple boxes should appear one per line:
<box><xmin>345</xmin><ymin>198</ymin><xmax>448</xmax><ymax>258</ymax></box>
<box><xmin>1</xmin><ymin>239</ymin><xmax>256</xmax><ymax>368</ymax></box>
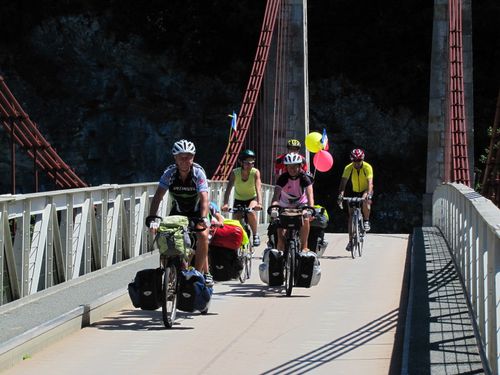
<box><xmin>0</xmin><ymin>181</ymin><xmax>273</xmax><ymax>305</ymax></box>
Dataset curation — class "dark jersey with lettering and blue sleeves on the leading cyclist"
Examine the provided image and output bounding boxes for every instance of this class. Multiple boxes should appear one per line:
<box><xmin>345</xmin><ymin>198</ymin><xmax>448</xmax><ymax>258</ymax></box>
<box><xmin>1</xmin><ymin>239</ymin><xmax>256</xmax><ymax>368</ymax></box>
<box><xmin>159</xmin><ymin>163</ymin><xmax>208</xmax><ymax>213</ymax></box>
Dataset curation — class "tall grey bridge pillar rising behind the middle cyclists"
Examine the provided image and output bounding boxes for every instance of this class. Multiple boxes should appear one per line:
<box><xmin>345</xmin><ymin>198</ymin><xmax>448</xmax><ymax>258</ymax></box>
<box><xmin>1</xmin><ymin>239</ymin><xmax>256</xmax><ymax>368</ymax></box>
<box><xmin>254</xmin><ymin>0</ymin><xmax>309</xmax><ymax>184</ymax></box>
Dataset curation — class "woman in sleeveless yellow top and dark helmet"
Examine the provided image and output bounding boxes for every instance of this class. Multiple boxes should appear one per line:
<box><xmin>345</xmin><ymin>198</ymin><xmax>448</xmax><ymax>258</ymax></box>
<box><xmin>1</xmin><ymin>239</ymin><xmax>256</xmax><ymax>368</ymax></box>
<box><xmin>222</xmin><ymin>150</ymin><xmax>262</xmax><ymax>246</ymax></box>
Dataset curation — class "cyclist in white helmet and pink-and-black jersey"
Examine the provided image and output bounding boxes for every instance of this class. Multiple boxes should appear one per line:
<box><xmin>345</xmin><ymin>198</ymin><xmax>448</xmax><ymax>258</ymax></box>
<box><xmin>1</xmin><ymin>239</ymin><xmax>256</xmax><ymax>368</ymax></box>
<box><xmin>272</xmin><ymin>154</ymin><xmax>314</xmax><ymax>251</ymax></box>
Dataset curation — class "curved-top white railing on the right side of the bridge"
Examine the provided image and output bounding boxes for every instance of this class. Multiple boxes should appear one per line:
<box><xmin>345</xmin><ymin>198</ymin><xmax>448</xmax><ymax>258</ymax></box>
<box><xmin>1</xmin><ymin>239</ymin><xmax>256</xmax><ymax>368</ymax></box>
<box><xmin>432</xmin><ymin>183</ymin><xmax>500</xmax><ymax>374</ymax></box>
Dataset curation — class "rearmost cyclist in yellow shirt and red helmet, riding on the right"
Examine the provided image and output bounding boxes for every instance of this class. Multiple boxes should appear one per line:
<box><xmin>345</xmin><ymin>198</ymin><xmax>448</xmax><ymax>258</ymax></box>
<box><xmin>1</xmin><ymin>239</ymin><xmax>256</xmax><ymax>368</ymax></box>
<box><xmin>337</xmin><ymin>148</ymin><xmax>373</xmax><ymax>251</ymax></box>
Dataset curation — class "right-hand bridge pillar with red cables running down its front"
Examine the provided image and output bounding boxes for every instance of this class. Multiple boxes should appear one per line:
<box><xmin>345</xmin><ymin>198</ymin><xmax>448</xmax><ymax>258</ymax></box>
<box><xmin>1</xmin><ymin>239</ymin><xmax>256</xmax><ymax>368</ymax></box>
<box><xmin>423</xmin><ymin>0</ymin><xmax>474</xmax><ymax>225</ymax></box>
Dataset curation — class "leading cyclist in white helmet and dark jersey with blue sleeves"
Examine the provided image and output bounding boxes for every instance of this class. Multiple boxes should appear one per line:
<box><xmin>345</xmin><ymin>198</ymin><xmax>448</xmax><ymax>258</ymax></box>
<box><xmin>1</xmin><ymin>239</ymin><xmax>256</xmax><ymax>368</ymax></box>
<box><xmin>149</xmin><ymin>139</ymin><xmax>213</xmax><ymax>286</ymax></box>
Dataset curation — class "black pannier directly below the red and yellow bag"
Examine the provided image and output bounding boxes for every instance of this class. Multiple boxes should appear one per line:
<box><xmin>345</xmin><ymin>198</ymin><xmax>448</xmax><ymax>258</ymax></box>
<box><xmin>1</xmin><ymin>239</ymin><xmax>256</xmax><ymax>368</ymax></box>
<box><xmin>208</xmin><ymin>245</ymin><xmax>243</xmax><ymax>281</ymax></box>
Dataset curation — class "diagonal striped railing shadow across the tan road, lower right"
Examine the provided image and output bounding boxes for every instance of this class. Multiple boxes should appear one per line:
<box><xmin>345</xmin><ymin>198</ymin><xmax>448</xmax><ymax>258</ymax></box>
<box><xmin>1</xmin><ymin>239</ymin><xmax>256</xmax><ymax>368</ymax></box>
<box><xmin>261</xmin><ymin>309</ymin><xmax>399</xmax><ymax>375</ymax></box>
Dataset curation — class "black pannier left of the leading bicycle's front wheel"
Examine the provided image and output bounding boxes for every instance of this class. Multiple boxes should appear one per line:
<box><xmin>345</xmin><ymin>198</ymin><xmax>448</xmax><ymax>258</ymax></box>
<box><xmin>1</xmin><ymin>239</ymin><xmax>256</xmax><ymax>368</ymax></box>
<box><xmin>128</xmin><ymin>268</ymin><xmax>163</xmax><ymax>310</ymax></box>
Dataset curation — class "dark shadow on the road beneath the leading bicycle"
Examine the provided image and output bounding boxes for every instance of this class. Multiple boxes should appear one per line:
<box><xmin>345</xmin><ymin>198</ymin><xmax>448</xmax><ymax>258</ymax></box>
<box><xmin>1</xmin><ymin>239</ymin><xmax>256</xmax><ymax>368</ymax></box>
<box><xmin>90</xmin><ymin>310</ymin><xmax>207</xmax><ymax>331</ymax></box>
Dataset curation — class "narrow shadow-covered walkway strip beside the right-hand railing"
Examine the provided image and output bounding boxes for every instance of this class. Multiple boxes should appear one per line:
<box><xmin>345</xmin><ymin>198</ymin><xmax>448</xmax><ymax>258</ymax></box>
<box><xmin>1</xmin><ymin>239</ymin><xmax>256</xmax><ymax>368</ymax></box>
<box><xmin>402</xmin><ymin>228</ymin><xmax>488</xmax><ymax>374</ymax></box>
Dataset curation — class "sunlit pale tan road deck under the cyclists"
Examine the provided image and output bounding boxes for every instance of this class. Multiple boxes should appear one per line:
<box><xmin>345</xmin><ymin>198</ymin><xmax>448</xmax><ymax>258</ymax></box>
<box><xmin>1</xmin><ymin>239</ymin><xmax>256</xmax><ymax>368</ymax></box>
<box><xmin>5</xmin><ymin>234</ymin><xmax>409</xmax><ymax>375</ymax></box>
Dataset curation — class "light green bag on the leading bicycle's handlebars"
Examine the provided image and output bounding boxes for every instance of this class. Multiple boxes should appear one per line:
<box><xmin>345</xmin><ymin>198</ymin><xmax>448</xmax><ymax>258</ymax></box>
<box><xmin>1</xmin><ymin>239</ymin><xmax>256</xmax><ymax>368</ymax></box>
<box><xmin>155</xmin><ymin>215</ymin><xmax>191</xmax><ymax>259</ymax></box>
